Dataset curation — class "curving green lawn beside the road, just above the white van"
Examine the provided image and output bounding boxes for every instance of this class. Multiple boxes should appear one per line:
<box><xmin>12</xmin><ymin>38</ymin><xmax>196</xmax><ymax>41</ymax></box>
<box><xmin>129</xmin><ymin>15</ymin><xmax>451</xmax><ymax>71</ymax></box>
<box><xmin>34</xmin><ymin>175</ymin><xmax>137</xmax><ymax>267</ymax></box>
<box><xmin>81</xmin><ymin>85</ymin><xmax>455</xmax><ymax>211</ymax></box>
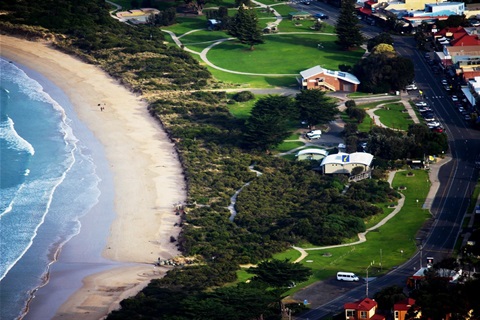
<box><xmin>275</xmin><ymin>170</ymin><xmax>431</xmax><ymax>290</ymax></box>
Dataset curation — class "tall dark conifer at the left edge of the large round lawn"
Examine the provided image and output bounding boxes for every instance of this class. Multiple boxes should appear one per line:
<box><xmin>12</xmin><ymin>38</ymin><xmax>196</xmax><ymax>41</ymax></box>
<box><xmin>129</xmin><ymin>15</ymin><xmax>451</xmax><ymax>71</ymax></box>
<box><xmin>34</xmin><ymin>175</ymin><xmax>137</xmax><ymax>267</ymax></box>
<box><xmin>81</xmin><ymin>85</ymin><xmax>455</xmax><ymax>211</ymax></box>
<box><xmin>228</xmin><ymin>6</ymin><xmax>264</xmax><ymax>50</ymax></box>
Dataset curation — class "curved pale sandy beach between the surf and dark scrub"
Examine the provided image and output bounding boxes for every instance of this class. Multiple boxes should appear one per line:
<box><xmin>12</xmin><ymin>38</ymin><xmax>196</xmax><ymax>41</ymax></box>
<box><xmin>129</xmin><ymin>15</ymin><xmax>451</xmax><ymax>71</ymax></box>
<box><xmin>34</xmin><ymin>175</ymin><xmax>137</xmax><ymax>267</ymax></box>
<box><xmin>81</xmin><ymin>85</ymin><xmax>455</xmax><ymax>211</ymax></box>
<box><xmin>0</xmin><ymin>35</ymin><xmax>186</xmax><ymax>319</ymax></box>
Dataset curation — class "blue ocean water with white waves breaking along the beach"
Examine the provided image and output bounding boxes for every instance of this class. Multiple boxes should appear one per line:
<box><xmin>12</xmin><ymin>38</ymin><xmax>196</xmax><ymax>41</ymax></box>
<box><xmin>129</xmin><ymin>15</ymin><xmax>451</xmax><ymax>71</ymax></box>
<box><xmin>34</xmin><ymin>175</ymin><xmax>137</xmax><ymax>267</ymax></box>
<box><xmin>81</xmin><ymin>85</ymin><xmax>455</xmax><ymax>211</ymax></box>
<box><xmin>0</xmin><ymin>58</ymin><xmax>109</xmax><ymax>320</ymax></box>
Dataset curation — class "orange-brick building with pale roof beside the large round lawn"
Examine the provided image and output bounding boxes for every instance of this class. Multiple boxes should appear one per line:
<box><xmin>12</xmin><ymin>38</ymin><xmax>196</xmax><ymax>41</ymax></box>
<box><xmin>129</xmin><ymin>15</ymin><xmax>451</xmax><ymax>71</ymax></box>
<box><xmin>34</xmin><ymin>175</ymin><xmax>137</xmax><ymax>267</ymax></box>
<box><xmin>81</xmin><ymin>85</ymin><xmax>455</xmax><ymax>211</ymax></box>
<box><xmin>297</xmin><ymin>66</ymin><xmax>360</xmax><ymax>92</ymax></box>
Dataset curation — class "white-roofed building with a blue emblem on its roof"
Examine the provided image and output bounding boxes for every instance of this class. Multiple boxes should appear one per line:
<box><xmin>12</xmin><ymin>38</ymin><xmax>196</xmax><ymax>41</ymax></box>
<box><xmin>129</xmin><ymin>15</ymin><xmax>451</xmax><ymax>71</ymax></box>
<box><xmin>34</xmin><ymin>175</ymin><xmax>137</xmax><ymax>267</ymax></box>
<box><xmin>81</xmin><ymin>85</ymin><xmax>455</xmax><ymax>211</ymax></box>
<box><xmin>320</xmin><ymin>152</ymin><xmax>373</xmax><ymax>174</ymax></box>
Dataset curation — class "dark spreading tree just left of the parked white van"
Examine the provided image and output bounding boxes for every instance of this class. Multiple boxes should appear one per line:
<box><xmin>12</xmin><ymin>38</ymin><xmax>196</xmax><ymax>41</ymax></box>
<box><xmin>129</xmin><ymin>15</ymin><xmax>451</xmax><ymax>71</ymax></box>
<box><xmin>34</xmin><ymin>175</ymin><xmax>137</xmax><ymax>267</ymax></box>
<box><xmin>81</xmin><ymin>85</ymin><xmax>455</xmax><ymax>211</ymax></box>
<box><xmin>247</xmin><ymin>259</ymin><xmax>312</xmax><ymax>288</ymax></box>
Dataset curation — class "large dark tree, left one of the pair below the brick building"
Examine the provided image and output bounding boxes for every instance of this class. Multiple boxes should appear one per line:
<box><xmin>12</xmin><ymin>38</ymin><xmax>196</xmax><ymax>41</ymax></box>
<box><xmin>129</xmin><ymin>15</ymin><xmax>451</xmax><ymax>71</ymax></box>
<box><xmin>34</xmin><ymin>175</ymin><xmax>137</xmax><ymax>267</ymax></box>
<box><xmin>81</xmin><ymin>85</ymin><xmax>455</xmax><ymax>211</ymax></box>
<box><xmin>245</xmin><ymin>96</ymin><xmax>293</xmax><ymax>150</ymax></box>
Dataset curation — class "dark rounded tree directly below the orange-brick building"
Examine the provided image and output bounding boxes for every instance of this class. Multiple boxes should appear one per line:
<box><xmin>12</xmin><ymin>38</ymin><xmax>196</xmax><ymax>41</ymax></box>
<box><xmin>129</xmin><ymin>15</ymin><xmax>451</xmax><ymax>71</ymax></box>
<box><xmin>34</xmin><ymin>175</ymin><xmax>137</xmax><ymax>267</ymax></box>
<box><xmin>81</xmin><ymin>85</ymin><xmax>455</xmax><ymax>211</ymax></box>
<box><xmin>295</xmin><ymin>90</ymin><xmax>338</xmax><ymax>126</ymax></box>
